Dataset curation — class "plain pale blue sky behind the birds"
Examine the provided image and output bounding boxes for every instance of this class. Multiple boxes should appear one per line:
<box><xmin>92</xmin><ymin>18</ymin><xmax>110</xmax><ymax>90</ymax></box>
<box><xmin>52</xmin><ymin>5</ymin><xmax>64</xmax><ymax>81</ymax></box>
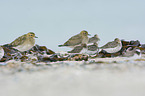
<box><xmin>0</xmin><ymin>0</ymin><xmax>145</xmax><ymax>51</ymax></box>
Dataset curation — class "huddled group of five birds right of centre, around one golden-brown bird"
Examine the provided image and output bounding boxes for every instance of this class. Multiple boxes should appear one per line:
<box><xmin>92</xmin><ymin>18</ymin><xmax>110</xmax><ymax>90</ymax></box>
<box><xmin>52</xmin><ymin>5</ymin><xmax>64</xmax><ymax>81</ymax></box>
<box><xmin>58</xmin><ymin>30</ymin><xmax>122</xmax><ymax>54</ymax></box>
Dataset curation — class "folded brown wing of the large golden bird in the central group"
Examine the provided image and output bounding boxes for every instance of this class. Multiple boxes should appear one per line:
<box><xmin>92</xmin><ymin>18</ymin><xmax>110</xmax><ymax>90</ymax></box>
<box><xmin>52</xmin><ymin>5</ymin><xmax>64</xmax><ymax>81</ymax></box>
<box><xmin>63</xmin><ymin>35</ymin><xmax>82</xmax><ymax>46</ymax></box>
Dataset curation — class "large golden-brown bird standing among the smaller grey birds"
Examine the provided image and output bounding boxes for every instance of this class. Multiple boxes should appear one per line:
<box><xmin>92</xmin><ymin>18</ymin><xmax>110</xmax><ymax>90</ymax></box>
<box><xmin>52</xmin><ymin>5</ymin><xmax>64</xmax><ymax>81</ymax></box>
<box><xmin>58</xmin><ymin>30</ymin><xmax>90</xmax><ymax>48</ymax></box>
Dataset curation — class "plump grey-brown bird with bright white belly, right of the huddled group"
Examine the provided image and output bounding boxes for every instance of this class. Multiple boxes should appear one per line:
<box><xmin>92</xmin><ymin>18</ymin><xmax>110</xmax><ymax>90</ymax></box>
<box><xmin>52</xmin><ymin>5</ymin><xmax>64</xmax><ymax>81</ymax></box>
<box><xmin>99</xmin><ymin>38</ymin><xmax>122</xmax><ymax>53</ymax></box>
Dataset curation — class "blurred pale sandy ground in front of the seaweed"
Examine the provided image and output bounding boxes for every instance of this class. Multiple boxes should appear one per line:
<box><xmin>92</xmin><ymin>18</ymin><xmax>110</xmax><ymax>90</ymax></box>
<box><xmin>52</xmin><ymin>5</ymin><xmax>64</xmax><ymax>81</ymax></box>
<box><xmin>0</xmin><ymin>57</ymin><xmax>145</xmax><ymax>96</ymax></box>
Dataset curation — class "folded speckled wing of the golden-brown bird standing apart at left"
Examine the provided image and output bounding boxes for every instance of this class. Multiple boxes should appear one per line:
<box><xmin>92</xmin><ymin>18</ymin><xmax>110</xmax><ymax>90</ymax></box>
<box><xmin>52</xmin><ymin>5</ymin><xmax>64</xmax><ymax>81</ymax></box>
<box><xmin>9</xmin><ymin>34</ymin><xmax>26</xmax><ymax>47</ymax></box>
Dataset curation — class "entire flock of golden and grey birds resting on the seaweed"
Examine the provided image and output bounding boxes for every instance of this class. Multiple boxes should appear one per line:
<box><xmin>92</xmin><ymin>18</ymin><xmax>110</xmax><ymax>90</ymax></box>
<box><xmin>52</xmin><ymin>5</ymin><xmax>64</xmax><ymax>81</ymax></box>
<box><xmin>0</xmin><ymin>30</ymin><xmax>140</xmax><ymax>58</ymax></box>
